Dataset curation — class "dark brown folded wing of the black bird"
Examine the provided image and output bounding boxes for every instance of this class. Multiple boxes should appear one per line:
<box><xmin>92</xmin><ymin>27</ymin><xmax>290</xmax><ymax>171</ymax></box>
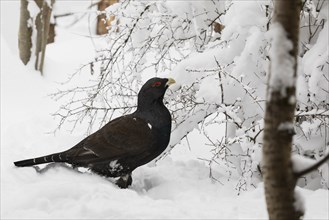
<box><xmin>67</xmin><ymin>115</ymin><xmax>155</xmax><ymax>162</ymax></box>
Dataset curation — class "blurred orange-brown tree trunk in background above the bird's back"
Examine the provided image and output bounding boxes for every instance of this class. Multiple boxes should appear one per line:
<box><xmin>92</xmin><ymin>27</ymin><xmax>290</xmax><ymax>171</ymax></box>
<box><xmin>96</xmin><ymin>0</ymin><xmax>118</xmax><ymax>35</ymax></box>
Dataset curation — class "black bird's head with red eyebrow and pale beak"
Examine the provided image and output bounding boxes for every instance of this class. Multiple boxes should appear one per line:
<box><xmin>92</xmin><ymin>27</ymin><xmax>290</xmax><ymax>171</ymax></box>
<box><xmin>138</xmin><ymin>77</ymin><xmax>176</xmax><ymax>107</ymax></box>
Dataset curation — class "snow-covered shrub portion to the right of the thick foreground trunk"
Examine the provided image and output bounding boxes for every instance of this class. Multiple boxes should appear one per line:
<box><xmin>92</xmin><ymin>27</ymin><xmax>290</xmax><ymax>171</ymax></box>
<box><xmin>294</xmin><ymin>0</ymin><xmax>329</xmax><ymax>189</ymax></box>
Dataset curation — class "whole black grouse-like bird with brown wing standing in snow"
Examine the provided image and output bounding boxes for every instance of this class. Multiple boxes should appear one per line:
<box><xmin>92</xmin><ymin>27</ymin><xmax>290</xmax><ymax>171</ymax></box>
<box><xmin>14</xmin><ymin>78</ymin><xmax>175</xmax><ymax>188</ymax></box>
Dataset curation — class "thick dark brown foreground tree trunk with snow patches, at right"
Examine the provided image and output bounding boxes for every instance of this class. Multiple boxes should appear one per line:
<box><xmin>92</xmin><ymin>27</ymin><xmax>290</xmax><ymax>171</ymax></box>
<box><xmin>263</xmin><ymin>0</ymin><xmax>302</xmax><ymax>220</ymax></box>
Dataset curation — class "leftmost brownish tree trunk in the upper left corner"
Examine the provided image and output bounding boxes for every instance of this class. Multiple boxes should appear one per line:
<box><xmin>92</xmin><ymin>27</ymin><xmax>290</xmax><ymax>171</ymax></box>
<box><xmin>18</xmin><ymin>0</ymin><xmax>32</xmax><ymax>65</ymax></box>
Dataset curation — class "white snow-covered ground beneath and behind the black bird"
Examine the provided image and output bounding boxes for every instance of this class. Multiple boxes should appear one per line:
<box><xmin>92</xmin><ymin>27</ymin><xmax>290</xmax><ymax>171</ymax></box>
<box><xmin>1</xmin><ymin>1</ymin><xmax>329</xmax><ymax>219</ymax></box>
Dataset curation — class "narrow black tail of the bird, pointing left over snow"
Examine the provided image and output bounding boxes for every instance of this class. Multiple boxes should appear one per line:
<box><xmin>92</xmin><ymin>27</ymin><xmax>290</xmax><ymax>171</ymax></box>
<box><xmin>14</xmin><ymin>152</ymin><xmax>67</xmax><ymax>167</ymax></box>
